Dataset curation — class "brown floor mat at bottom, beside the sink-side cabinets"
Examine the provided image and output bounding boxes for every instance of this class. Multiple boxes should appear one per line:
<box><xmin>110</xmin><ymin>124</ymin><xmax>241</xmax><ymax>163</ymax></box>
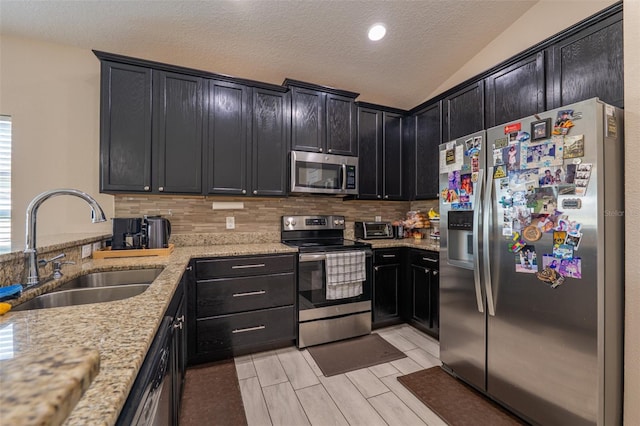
<box><xmin>180</xmin><ymin>359</ymin><xmax>247</xmax><ymax>426</ymax></box>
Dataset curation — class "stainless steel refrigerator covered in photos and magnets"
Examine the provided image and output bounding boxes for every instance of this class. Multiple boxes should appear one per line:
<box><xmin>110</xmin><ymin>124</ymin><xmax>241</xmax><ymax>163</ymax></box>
<box><xmin>440</xmin><ymin>99</ymin><xmax>624</xmax><ymax>426</ymax></box>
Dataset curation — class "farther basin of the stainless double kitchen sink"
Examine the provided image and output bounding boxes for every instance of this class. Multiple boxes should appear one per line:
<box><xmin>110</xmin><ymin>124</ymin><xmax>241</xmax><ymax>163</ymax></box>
<box><xmin>53</xmin><ymin>268</ymin><xmax>163</xmax><ymax>292</ymax></box>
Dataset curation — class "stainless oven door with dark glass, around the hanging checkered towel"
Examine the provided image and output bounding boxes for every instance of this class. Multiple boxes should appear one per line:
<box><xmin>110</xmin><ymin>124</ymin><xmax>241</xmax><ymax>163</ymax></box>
<box><xmin>298</xmin><ymin>250</ymin><xmax>373</xmax><ymax>310</ymax></box>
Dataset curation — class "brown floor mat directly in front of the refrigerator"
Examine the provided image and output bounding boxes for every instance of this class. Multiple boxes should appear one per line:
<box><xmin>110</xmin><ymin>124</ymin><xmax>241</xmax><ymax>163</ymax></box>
<box><xmin>398</xmin><ymin>367</ymin><xmax>527</xmax><ymax>426</ymax></box>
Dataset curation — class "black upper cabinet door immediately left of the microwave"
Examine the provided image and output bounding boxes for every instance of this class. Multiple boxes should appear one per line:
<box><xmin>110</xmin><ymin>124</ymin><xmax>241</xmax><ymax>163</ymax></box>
<box><xmin>251</xmin><ymin>88</ymin><xmax>291</xmax><ymax>196</ymax></box>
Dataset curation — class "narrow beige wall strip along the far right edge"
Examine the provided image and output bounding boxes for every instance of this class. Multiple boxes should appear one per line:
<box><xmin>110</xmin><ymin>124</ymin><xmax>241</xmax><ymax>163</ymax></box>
<box><xmin>623</xmin><ymin>0</ymin><xmax>640</xmax><ymax>426</ymax></box>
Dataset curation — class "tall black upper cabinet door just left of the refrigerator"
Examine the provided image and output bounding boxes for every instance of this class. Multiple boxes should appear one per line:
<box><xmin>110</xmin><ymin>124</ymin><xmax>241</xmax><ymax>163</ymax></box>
<box><xmin>408</xmin><ymin>102</ymin><xmax>442</xmax><ymax>200</ymax></box>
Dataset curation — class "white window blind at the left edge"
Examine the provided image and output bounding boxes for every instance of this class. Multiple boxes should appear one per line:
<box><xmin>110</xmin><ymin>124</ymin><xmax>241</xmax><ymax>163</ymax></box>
<box><xmin>0</xmin><ymin>115</ymin><xmax>11</xmax><ymax>253</ymax></box>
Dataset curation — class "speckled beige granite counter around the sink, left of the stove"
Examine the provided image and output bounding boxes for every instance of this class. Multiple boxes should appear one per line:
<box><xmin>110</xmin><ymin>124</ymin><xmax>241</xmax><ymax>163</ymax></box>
<box><xmin>0</xmin><ymin>243</ymin><xmax>296</xmax><ymax>426</ymax></box>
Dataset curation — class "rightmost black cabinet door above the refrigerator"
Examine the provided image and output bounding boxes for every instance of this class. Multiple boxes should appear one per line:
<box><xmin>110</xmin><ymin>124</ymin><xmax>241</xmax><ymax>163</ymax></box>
<box><xmin>547</xmin><ymin>12</ymin><xmax>624</xmax><ymax>109</ymax></box>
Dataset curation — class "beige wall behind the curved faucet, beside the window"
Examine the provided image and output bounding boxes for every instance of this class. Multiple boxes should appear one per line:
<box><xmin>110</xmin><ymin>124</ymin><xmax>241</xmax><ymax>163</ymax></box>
<box><xmin>0</xmin><ymin>36</ymin><xmax>113</xmax><ymax>250</ymax></box>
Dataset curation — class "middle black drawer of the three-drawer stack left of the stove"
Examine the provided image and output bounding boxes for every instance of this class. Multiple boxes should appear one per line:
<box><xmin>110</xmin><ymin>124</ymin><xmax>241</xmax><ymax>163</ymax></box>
<box><xmin>196</xmin><ymin>272</ymin><xmax>295</xmax><ymax>318</ymax></box>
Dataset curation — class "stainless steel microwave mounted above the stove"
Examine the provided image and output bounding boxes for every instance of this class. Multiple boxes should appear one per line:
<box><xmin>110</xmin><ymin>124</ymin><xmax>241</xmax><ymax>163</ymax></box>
<box><xmin>290</xmin><ymin>151</ymin><xmax>358</xmax><ymax>195</ymax></box>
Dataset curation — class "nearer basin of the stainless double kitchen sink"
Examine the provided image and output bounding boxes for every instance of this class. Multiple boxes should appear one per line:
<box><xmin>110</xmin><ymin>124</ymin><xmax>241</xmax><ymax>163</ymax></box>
<box><xmin>13</xmin><ymin>284</ymin><xmax>151</xmax><ymax>311</ymax></box>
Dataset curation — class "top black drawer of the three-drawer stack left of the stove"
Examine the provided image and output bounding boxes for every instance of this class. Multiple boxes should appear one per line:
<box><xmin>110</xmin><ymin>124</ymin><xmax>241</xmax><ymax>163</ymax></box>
<box><xmin>196</xmin><ymin>255</ymin><xmax>295</xmax><ymax>280</ymax></box>
